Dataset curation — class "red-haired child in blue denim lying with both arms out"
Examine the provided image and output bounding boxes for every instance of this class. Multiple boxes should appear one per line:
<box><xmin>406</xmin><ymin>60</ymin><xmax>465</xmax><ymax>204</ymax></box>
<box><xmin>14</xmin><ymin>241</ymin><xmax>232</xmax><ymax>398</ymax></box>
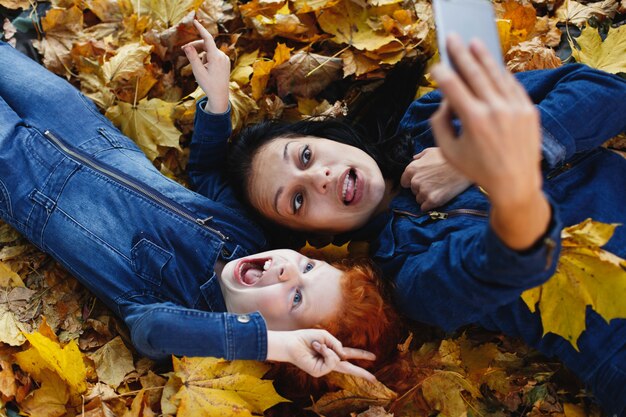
<box><xmin>0</xmin><ymin>35</ymin><xmax>396</xmax><ymax>379</ymax></box>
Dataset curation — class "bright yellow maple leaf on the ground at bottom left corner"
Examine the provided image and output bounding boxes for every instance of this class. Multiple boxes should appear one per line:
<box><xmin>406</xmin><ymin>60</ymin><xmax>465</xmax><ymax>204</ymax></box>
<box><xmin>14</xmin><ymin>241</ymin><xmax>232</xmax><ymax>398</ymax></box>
<box><xmin>15</xmin><ymin>332</ymin><xmax>87</xmax><ymax>394</ymax></box>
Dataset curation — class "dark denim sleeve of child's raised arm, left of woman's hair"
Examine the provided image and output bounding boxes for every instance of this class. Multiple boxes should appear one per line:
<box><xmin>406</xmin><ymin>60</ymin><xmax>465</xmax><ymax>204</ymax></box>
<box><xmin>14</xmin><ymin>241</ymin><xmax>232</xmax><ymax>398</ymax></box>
<box><xmin>187</xmin><ymin>97</ymin><xmax>232</xmax><ymax>198</ymax></box>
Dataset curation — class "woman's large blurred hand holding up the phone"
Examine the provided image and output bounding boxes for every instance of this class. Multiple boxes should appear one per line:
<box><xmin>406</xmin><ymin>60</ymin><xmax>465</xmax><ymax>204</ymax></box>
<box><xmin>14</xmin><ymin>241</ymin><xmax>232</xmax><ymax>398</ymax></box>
<box><xmin>431</xmin><ymin>36</ymin><xmax>550</xmax><ymax>250</ymax></box>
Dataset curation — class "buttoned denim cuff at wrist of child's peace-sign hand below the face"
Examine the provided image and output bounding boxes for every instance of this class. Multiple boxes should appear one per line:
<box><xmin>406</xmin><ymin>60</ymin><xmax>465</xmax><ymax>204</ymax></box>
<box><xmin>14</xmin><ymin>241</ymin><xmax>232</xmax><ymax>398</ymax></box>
<box><xmin>225</xmin><ymin>312</ymin><xmax>267</xmax><ymax>361</ymax></box>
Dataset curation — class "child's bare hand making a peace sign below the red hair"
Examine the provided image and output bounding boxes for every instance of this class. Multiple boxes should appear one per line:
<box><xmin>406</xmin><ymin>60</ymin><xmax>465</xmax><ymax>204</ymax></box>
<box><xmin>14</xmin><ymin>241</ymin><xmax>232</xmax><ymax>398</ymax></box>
<box><xmin>267</xmin><ymin>329</ymin><xmax>376</xmax><ymax>381</ymax></box>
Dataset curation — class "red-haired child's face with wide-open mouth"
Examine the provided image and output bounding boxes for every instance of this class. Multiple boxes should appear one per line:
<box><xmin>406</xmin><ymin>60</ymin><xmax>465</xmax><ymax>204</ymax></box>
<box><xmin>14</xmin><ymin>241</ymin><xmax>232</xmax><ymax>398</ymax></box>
<box><xmin>219</xmin><ymin>249</ymin><xmax>343</xmax><ymax>330</ymax></box>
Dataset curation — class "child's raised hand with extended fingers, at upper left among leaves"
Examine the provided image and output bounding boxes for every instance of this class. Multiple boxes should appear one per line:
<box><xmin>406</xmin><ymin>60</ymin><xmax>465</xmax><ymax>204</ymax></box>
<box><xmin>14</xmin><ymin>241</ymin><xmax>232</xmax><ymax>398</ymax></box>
<box><xmin>182</xmin><ymin>20</ymin><xmax>230</xmax><ymax>113</ymax></box>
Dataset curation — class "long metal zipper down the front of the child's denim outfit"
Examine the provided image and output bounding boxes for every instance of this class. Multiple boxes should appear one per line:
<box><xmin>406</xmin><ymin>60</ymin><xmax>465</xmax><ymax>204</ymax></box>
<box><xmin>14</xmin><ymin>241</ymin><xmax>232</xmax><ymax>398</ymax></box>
<box><xmin>43</xmin><ymin>130</ymin><xmax>230</xmax><ymax>240</ymax></box>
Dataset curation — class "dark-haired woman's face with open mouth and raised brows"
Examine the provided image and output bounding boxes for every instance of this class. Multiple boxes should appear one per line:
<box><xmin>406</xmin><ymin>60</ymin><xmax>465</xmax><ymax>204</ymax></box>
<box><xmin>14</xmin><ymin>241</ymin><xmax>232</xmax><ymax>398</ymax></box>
<box><xmin>248</xmin><ymin>136</ymin><xmax>385</xmax><ymax>233</ymax></box>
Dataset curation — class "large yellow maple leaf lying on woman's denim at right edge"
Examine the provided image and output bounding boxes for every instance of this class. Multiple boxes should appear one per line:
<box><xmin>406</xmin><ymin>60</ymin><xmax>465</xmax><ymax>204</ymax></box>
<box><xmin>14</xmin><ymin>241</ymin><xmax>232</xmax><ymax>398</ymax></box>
<box><xmin>522</xmin><ymin>219</ymin><xmax>626</xmax><ymax>350</ymax></box>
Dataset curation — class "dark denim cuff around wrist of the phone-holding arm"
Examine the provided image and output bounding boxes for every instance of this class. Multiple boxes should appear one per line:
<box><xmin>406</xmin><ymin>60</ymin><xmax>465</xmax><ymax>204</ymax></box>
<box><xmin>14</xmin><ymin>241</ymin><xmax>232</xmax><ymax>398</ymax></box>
<box><xmin>485</xmin><ymin>197</ymin><xmax>562</xmax><ymax>288</ymax></box>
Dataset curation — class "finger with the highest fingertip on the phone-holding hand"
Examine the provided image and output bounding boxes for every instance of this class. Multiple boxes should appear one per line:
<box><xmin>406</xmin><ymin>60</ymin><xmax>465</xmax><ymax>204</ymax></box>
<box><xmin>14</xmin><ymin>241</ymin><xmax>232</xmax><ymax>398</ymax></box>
<box><xmin>446</xmin><ymin>34</ymin><xmax>497</xmax><ymax>99</ymax></box>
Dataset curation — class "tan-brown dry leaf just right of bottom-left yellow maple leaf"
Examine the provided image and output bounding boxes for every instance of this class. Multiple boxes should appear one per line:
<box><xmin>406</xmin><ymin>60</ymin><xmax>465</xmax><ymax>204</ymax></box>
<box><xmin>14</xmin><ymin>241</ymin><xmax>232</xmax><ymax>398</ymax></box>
<box><xmin>89</xmin><ymin>336</ymin><xmax>135</xmax><ymax>388</ymax></box>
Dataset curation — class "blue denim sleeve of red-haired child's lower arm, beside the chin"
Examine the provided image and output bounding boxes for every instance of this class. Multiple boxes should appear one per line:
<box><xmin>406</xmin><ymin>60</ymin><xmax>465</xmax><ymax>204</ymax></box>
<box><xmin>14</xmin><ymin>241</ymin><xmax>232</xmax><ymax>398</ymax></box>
<box><xmin>124</xmin><ymin>303</ymin><xmax>267</xmax><ymax>361</ymax></box>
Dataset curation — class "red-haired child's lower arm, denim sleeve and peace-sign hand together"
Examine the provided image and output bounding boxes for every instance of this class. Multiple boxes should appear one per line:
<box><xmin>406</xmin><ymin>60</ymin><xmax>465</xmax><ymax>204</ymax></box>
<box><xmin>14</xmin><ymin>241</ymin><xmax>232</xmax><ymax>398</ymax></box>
<box><xmin>122</xmin><ymin>302</ymin><xmax>376</xmax><ymax>380</ymax></box>
